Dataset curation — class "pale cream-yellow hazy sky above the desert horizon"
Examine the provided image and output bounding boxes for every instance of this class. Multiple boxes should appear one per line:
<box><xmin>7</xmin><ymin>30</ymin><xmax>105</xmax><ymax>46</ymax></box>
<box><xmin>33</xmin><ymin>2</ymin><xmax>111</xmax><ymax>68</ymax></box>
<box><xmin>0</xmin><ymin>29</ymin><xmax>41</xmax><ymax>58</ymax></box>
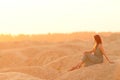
<box><xmin>0</xmin><ymin>0</ymin><xmax>120</xmax><ymax>34</ymax></box>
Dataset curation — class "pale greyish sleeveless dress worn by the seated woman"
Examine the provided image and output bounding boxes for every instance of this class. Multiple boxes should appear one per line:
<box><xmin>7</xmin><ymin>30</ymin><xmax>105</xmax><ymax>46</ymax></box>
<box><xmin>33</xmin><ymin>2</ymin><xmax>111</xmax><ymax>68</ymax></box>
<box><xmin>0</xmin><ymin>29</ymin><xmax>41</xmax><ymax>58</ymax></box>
<box><xmin>81</xmin><ymin>47</ymin><xmax>103</xmax><ymax>66</ymax></box>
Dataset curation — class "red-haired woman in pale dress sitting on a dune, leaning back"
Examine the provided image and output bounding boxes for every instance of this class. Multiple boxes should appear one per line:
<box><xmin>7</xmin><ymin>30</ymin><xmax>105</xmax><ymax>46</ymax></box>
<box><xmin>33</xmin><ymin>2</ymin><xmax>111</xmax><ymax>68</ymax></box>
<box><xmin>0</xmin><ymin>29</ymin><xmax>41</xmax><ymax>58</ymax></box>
<box><xmin>69</xmin><ymin>35</ymin><xmax>113</xmax><ymax>71</ymax></box>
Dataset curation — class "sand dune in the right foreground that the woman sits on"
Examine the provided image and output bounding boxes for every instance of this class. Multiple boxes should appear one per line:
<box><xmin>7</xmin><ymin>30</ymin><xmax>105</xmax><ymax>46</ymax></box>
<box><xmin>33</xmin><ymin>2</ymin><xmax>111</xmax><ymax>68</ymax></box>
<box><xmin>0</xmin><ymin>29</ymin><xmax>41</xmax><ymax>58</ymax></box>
<box><xmin>56</xmin><ymin>63</ymin><xmax>120</xmax><ymax>80</ymax></box>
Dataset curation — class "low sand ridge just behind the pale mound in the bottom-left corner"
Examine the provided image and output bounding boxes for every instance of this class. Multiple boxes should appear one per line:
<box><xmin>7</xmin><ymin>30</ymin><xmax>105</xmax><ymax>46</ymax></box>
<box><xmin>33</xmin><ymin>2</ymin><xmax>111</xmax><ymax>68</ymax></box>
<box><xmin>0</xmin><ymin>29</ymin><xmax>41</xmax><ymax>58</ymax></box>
<box><xmin>0</xmin><ymin>66</ymin><xmax>59</xmax><ymax>80</ymax></box>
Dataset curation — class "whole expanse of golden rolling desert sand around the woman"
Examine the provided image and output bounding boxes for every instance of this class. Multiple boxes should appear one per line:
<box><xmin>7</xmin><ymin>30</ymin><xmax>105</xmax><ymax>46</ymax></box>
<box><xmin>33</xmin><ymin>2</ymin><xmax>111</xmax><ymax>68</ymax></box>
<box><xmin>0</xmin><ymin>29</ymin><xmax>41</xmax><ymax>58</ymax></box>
<box><xmin>0</xmin><ymin>32</ymin><xmax>120</xmax><ymax>80</ymax></box>
